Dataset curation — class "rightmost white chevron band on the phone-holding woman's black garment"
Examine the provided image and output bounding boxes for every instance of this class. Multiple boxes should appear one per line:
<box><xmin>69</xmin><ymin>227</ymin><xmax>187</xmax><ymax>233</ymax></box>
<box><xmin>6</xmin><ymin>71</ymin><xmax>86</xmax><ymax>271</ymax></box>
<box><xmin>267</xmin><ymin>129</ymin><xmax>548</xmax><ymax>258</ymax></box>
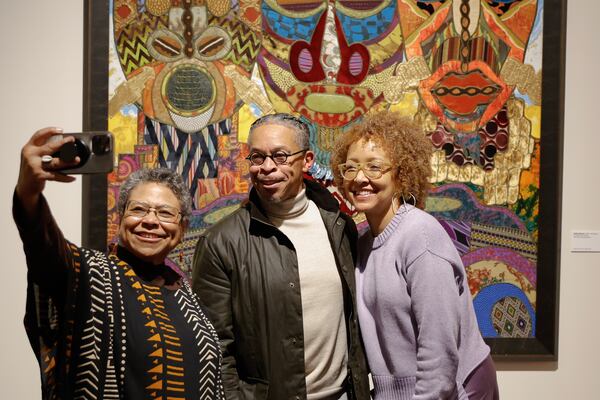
<box><xmin>176</xmin><ymin>280</ymin><xmax>224</xmax><ymax>400</ymax></box>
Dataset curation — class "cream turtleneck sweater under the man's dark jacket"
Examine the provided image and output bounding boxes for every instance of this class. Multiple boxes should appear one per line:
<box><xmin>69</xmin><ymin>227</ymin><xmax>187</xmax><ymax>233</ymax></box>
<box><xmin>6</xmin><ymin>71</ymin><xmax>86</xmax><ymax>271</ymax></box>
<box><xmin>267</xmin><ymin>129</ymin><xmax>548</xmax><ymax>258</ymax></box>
<box><xmin>263</xmin><ymin>189</ymin><xmax>348</xmax><ymax>400</ymax></box>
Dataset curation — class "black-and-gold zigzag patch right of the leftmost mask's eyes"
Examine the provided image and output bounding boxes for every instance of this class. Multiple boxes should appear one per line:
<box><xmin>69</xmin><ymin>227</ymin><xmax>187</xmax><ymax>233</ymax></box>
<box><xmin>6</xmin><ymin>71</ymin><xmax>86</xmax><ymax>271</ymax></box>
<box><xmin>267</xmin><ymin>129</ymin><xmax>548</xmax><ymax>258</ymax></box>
<box><xmin>209</xmin><ymin>17</ymin><xmax>261</xmax><ymax>72</ymax></box>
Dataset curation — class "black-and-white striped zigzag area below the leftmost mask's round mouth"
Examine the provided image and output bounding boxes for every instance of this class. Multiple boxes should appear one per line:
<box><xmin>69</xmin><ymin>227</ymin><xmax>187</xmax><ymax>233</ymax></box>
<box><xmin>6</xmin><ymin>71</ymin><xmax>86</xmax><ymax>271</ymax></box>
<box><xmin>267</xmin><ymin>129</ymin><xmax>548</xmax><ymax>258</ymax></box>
<box><xmin>144</xmin><ymin>117</ymin><xmax>231</xmax><ymax>207</ymax></box>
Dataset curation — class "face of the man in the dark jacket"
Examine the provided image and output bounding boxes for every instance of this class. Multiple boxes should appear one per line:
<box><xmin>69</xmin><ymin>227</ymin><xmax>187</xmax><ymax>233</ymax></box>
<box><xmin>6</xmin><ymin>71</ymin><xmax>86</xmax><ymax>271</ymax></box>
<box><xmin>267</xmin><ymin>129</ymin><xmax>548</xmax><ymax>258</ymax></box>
<box><xmin>249</xmin><ymin>123</ymin><xmax>314</xmax><ymax>203</ymax></box>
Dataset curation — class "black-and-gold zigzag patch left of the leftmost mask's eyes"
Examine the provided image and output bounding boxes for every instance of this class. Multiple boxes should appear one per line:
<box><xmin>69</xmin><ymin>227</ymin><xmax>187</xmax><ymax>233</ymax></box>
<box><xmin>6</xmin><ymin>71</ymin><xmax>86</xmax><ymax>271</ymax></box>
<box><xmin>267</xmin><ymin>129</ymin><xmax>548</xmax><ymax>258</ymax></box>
<box><xmin>116</xmin><ymin>14</ymin><xmax>167</xmax><ymax>76</ymax></box>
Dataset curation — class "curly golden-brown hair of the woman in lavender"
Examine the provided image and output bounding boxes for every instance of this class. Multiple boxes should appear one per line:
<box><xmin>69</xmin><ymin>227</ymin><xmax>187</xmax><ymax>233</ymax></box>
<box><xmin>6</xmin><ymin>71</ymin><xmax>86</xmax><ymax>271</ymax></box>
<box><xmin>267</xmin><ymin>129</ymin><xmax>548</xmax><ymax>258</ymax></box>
<box><xmin>331</xmin><ymin>111</ymin><xmax>433</xmax><ymax>208</ymax></box>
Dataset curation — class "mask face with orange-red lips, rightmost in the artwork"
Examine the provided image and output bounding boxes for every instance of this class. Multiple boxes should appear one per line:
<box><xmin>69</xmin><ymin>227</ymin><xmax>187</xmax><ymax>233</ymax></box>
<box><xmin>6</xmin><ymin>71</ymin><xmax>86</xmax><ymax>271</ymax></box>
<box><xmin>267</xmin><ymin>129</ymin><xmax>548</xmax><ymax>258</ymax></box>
<box><xmin>398</xmin><ymin>0</ymin><xmax>537</xmax><ymax>132</ymax></box>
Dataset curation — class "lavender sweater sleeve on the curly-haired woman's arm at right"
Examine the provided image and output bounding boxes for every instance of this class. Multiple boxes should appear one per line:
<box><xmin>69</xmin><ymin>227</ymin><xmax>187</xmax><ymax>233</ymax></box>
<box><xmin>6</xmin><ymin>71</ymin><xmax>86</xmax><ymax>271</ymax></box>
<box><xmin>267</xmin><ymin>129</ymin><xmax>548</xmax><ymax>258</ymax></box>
<box><xmin>407</xmin><ymin>251</ymin><xmax>460</xmax><ymax>400</ymax></box>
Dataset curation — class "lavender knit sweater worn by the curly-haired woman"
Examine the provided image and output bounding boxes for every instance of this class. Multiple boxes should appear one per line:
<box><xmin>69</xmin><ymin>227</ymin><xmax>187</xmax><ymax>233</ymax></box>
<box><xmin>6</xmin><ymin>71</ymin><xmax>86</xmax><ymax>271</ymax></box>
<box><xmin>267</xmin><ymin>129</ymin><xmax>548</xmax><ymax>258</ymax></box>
<box><xmin>356</xmin><ymin>205</ymin><xmax>490</xmax><ymax>400</ymax></box>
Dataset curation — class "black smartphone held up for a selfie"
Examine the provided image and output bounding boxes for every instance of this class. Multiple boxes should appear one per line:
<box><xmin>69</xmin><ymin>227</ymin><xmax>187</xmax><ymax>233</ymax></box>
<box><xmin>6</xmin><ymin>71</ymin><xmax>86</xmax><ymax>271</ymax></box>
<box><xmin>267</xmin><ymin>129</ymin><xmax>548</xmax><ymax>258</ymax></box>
<box><xmin>52</xmin><ymin>131</ymin><xmax>114</xmax><ymax>175</ymax></box>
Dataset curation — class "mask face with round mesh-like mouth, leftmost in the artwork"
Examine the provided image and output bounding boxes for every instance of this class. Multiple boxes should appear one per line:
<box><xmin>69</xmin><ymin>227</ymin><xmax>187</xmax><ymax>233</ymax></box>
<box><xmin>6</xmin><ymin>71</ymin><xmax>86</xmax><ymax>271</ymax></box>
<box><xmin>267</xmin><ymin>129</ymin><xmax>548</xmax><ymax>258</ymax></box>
<box><xmin>111</xmin><ymin>0</ymin><xmax>260</xmax><ymax>133</ymax></box>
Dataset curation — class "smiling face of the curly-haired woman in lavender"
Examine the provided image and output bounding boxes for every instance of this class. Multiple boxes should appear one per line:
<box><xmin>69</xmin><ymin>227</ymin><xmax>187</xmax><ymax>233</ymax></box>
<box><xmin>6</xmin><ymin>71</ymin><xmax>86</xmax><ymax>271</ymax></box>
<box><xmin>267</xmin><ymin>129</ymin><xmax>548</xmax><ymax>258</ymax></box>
<box><xmin>344</xmin><ymin>139</ymin><xmax>397</xmax><ymax>234</ymax></box>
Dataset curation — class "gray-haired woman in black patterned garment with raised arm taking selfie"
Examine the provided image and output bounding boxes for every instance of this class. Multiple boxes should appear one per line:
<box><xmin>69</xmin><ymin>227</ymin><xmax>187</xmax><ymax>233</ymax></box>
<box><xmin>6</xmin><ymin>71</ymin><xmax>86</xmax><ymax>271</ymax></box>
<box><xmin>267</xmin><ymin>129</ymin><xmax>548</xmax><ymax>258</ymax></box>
<box><xmin>13</xmin><ymin>128</ymin><xmax>224</xmax><ymax>399</ymax></box>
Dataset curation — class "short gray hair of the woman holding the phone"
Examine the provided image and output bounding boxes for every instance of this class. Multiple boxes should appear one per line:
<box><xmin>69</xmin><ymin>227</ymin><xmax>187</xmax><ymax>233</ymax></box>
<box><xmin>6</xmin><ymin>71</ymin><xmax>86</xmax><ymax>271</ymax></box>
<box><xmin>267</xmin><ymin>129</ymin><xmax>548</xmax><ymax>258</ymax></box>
<box><xmin>117</xmin><ymin>168</ymin><xmax>192</xmax><ymax>221</ymax></box>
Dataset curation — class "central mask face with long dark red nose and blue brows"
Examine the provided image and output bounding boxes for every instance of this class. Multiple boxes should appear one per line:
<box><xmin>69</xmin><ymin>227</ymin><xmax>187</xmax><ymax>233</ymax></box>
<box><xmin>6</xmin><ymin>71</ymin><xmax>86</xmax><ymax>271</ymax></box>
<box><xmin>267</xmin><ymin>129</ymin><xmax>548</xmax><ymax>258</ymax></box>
<box><xmin>258</xmin><ymin>0</ymin><xmax>402</xmax><ymax>128</ymax></box>
